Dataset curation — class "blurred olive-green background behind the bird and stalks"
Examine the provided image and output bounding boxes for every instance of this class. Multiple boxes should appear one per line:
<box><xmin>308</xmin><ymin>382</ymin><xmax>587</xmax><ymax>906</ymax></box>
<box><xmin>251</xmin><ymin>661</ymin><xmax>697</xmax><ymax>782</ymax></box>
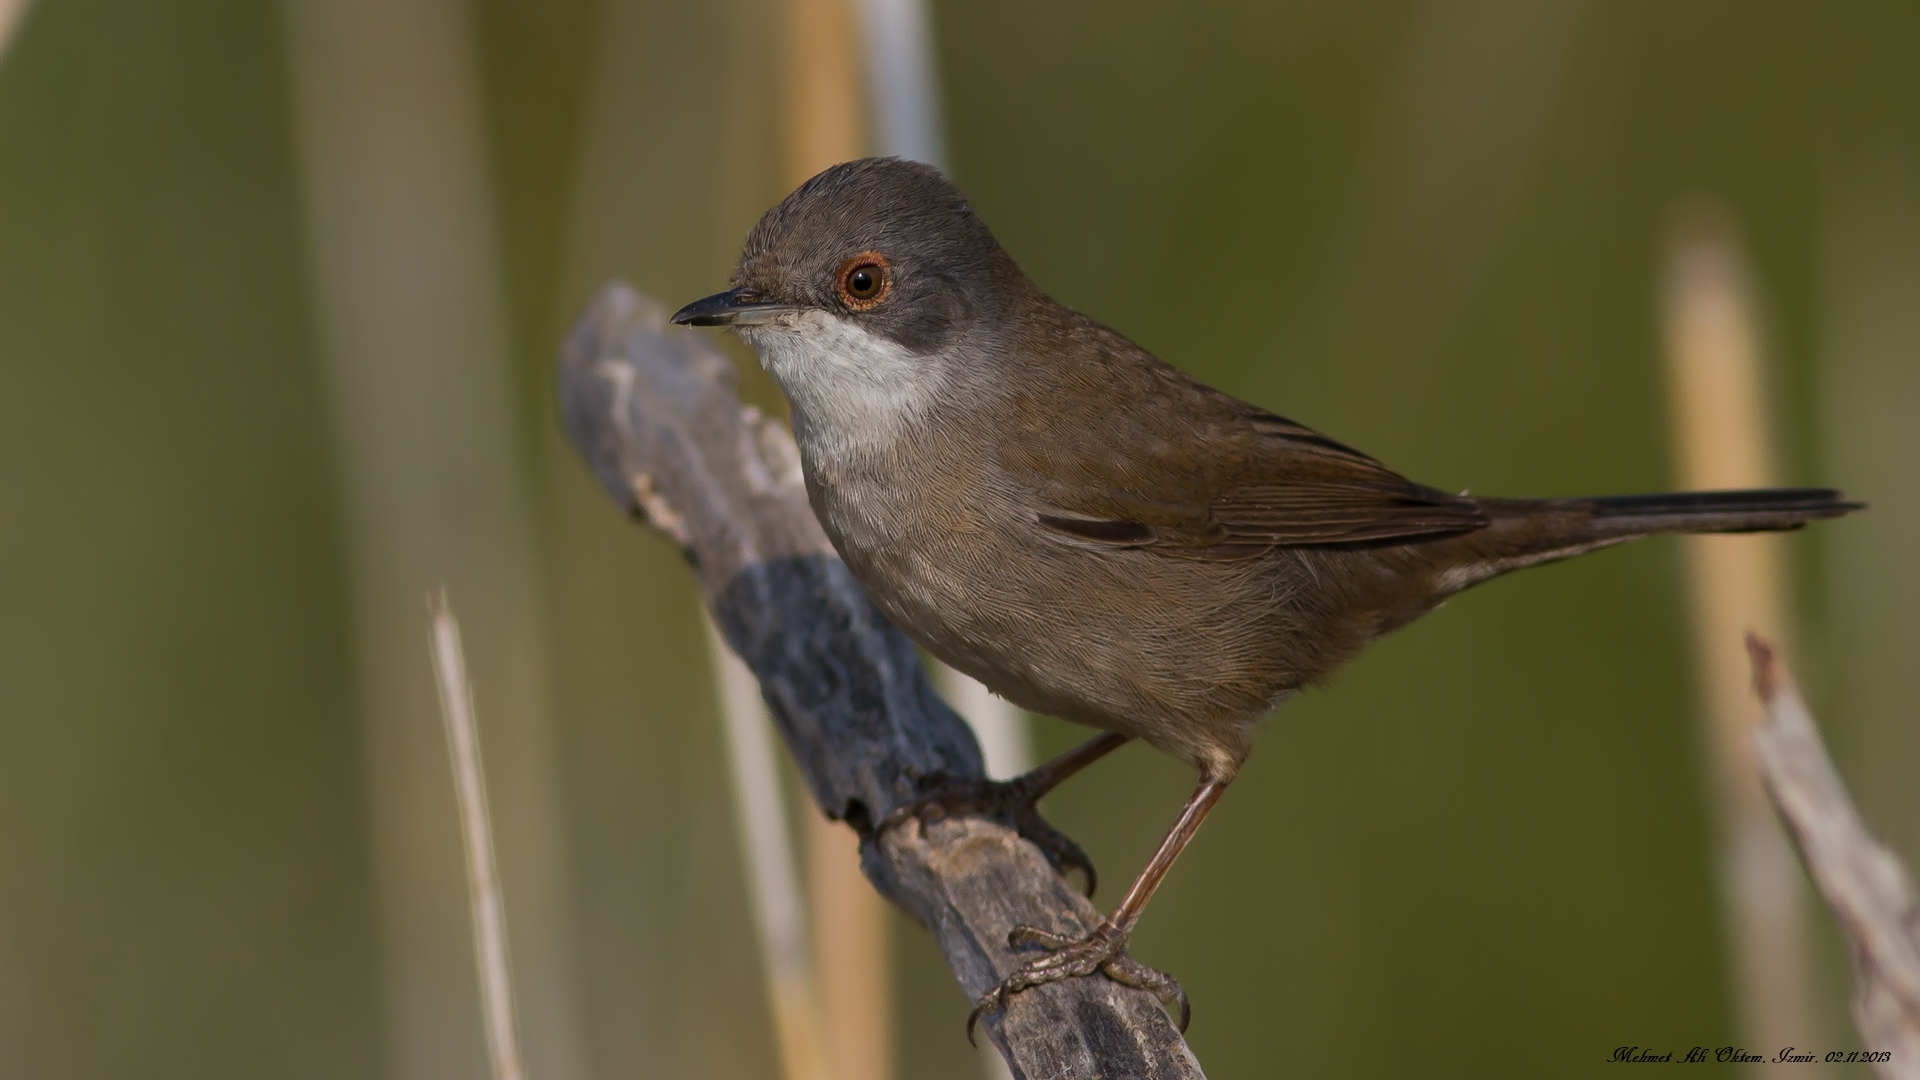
<box><xmin>0</xmin><ymin>0</ymin><xmax>1920</xmax><ymax>1078</ymax></box>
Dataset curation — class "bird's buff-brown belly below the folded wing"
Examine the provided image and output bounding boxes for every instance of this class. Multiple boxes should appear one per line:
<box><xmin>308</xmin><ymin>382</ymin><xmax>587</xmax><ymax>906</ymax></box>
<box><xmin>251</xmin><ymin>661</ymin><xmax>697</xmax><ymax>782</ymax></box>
<box><xmin>810</xmin><ymin>466</ymin><xmax>1311</xmax><ymax>769</ymax></box>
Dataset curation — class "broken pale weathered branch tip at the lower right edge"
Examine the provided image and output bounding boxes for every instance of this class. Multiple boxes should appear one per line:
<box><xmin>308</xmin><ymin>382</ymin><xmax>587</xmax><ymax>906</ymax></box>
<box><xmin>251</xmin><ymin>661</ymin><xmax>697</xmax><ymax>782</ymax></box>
<box><xmin>1747</xmin><ymin>634</ymin><xmax>1920</xmax><ymax>1080</ymax></box>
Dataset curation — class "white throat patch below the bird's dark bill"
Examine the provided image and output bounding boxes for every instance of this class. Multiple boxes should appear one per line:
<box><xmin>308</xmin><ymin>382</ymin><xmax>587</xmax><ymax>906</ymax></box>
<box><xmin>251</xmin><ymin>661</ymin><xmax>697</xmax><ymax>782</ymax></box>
<box><xmin>741</xmin><ymin>311</ymin><xmax>945</xmax><ymax>457</ymax></box>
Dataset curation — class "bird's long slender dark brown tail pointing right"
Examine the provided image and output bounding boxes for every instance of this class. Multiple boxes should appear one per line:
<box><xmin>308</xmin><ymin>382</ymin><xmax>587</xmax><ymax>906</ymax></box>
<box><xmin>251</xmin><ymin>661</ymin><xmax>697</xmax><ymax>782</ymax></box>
<box><xmin>1438</xmin><ymin>488</ymin><xmax>1866</xmax><ymax>592</ymax></box>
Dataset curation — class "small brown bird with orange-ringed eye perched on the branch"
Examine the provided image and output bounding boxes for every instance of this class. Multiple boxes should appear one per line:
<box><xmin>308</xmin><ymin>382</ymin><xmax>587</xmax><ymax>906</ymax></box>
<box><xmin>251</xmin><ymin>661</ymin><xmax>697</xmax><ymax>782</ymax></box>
<box><xmin>674</xmin><ymin>160</ymin><xmax>1859</xmax><ymax>1028</ymax></box>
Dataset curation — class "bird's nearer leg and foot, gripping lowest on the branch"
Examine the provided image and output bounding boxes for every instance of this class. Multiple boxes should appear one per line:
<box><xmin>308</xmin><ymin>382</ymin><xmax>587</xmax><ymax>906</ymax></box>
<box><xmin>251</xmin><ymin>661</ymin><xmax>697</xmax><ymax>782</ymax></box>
<box><xmin>966</xmin><ymin>778</ymin><xmax>1227</xmax><ymax>1042</ymax></box>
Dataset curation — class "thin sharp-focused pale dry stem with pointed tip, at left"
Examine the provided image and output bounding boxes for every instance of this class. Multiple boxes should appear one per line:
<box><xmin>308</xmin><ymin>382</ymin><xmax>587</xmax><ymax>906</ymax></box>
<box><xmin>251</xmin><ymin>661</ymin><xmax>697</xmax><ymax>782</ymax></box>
<box><xmin>426</xmin><ymin>590</ymin><xmax>526</xmax><ymax>1080</ymax></box>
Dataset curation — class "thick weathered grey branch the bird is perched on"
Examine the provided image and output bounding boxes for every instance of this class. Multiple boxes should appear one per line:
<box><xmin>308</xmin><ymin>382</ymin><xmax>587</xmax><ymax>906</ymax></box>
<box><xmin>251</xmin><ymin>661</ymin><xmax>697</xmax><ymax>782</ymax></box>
<box><xmin>561</xmin><ymin>284</ymin><xmax>1200</xmax><ymax>1080</ymax></box>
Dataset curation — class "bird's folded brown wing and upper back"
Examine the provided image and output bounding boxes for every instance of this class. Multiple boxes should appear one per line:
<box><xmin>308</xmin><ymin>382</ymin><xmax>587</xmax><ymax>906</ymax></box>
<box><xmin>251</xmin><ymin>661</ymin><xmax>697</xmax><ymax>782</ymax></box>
<box><xmin>1000</xmin><ymin>305</ymin><xmax>1488</xmax><ymax>559</ymax></box>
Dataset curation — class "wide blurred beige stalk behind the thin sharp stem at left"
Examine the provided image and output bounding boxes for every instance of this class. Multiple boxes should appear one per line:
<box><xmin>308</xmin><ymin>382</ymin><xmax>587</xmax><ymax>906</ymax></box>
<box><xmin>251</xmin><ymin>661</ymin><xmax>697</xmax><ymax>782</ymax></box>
<box><xmin>280</xmin><ymin>0</ymin><xmax>588</xmax><ymax>1080</ymax></box>
